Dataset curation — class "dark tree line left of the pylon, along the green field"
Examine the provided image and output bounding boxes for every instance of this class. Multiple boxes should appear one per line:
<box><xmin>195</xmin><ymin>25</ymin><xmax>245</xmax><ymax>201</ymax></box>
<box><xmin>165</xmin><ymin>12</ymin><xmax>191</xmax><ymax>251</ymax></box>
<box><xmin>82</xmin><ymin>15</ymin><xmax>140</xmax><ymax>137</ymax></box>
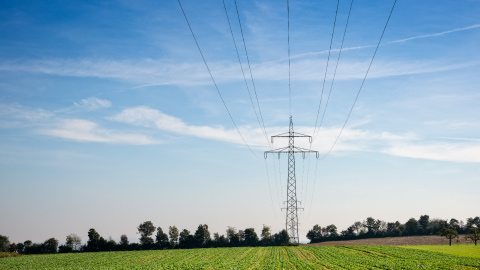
<box><xmin>0</xmin><ymin>221</ymin><xmax>289</xmax><ymax>254</ymax></box>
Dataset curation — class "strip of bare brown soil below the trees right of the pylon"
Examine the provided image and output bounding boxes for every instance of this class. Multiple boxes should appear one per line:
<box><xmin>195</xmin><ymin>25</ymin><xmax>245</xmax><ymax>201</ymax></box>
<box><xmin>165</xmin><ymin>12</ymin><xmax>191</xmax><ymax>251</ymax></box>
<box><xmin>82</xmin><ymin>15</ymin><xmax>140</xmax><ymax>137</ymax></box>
<box><xmin>307</xmin><ymin>235</ymin><xmax>473</xmax><ymax>246</ymax></box>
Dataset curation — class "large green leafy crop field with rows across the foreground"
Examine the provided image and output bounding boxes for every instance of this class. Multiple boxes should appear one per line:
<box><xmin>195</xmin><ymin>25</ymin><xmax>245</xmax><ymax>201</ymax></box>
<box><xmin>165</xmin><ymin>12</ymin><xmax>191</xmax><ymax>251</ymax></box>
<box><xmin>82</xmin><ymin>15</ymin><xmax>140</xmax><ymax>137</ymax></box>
<box><xmin>0</xmin><ymin>246</ymin><xmax>480</xmax><ymax>269</ymax></box>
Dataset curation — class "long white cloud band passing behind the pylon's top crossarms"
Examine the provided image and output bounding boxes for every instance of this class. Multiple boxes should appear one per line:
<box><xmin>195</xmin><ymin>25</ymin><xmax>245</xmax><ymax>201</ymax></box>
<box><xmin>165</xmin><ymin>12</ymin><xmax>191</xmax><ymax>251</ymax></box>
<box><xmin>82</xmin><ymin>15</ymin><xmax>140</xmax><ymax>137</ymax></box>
<box><xmin>109</xmin><ymin>106</ymin><xmax>480</xmax><ymax>162</ymax></box>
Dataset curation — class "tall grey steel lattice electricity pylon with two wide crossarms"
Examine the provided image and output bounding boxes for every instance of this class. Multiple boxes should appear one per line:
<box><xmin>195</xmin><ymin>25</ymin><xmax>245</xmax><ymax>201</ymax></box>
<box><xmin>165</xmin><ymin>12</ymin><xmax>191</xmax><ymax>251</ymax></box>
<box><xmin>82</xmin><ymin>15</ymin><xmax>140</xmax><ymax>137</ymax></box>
<box><xmin>264</xmin><ymin>116</ymin><xmax>318</xmax><ymax>243</ymax></box>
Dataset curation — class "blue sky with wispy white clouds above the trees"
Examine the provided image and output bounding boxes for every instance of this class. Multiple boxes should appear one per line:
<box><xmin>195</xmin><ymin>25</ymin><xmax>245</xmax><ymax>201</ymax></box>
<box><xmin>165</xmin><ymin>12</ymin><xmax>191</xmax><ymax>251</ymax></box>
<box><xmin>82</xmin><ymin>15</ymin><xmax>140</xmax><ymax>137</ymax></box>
<box><xmin>0</xmin><ymin>0</ymin><xmax>480</xmax><ymax>243</ymax></box>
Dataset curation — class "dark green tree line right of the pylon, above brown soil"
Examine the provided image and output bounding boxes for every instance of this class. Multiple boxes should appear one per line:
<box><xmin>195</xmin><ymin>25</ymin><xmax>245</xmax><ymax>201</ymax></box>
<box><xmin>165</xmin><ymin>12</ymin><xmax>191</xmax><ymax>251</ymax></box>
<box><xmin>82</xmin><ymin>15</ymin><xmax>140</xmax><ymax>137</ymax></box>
<box><xmin>307</xmin><ymin>215</ymin><xmax>480</xmax><ymax>245</ymax></box>
